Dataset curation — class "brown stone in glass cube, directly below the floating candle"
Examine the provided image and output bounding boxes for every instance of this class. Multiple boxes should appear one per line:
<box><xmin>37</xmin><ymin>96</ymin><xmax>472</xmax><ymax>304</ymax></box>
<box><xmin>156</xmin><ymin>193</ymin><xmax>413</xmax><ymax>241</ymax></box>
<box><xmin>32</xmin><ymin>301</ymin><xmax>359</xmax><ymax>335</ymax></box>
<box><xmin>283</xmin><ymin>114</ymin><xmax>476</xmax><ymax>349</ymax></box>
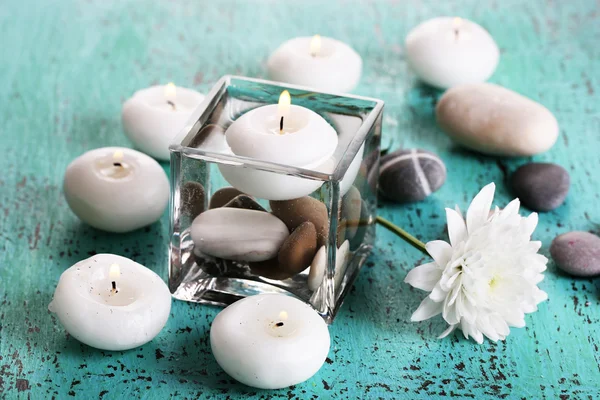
<box><xmin>269</xmin><ymin>196</ymin><xmax>329</xmax><ymax>246</ymax></box>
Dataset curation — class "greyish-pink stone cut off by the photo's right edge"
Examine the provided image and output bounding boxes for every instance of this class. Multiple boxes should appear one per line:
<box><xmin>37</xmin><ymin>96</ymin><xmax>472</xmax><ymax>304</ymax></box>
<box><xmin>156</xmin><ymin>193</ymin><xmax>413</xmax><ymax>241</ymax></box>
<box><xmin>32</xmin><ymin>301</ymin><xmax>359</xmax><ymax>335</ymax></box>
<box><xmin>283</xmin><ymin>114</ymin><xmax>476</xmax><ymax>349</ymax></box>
<box><xmin>550</xmin><ymin>231</ymin><xmax>600</xmax><ymax>277</ymax></box>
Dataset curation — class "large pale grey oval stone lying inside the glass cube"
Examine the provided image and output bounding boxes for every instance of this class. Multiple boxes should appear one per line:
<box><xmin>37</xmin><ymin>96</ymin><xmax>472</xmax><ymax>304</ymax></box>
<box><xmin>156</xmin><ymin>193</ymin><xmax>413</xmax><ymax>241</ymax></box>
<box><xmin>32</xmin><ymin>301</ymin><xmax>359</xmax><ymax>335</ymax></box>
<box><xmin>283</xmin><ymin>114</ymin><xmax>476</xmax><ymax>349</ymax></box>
<box><xmin>191</xmin><ymin>208</ymin><xmax>289</xmax><ymax>262</ymax></box>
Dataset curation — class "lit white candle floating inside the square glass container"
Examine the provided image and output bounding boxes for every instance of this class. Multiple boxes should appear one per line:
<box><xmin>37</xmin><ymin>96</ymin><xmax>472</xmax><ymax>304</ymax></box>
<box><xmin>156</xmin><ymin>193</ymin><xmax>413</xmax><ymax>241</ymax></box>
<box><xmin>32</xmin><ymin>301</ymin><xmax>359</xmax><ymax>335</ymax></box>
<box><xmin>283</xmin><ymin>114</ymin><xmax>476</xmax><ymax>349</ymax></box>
<box><xmin>219</xmin><ymin>91</ymin><xmax>338</xmax><ymax>200</ymax></box>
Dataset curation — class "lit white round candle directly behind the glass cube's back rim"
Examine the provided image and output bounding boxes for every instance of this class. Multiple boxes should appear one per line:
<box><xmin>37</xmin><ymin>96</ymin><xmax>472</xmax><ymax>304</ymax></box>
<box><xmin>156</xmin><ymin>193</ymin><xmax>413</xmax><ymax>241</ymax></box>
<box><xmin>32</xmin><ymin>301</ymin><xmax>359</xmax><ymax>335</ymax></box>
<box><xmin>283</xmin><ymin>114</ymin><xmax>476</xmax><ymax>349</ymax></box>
<box><xmin>267</xmin><ymin>35</ymin><xmax>362</xmax><ymax>92</ymax></box>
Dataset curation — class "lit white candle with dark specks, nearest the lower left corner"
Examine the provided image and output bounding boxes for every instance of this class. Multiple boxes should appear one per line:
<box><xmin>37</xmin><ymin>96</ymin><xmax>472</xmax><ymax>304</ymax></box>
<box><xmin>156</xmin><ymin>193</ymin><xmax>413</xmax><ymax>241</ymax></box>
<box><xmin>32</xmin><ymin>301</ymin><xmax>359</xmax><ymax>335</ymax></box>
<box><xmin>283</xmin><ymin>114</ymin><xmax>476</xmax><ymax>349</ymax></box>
<box><xmin>48</xmin><ymin>254</ymin><xmax>171</xmax><ymax>350</ymax></box>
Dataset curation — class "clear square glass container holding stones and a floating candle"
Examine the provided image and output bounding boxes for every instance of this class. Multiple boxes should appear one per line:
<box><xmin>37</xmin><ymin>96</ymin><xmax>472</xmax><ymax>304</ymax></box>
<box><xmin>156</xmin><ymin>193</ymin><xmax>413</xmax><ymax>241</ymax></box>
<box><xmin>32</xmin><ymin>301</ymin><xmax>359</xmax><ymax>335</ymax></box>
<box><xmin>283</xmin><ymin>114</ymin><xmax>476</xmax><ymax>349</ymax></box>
<box><xmin>169</xmin><ymin>76</ymin><xmax>383</xmax><ymax>323</ymax></box>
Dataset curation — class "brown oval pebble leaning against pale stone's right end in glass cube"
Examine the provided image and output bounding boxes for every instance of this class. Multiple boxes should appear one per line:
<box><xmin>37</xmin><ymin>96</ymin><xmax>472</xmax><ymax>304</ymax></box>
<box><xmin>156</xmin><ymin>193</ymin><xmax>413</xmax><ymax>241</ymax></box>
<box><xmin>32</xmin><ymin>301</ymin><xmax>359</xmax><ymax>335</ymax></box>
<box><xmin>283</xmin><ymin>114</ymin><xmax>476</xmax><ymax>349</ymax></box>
<box><xmin>277</xmin><ymin>221</ymin><xmax>317</xmax><ymax>276</ymax></box>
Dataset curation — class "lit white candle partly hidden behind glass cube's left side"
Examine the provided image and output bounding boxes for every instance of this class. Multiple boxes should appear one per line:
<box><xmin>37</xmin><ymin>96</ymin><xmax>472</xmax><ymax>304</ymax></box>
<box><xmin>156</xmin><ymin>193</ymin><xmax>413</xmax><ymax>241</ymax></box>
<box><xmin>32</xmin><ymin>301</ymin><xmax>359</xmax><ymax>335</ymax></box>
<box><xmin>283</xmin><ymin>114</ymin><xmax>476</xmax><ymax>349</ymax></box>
<box><xmin>122</xmin><ymin>83</ymin><xmax>204</xmax><ymax>160</ymax></box>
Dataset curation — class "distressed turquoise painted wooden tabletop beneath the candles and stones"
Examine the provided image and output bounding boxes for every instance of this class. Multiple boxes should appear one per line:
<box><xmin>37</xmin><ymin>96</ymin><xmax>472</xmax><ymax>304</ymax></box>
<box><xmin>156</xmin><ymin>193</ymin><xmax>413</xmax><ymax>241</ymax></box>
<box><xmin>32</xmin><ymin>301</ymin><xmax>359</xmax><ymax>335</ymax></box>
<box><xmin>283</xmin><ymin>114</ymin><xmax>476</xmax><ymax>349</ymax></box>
<box><xmin>0</xmin><ymin>0</ymin><xmax>600</xmax><ymax>399</ymax></box>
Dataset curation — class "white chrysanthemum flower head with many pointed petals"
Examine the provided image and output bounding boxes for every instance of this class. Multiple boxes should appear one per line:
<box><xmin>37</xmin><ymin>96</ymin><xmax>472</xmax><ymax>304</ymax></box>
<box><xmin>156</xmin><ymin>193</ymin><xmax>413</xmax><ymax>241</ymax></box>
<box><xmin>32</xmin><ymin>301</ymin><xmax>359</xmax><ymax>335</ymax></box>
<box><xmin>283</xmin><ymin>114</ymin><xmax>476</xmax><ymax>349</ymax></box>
<box><xmin>404</xmin><ymin>183</ymin><xmax>548</xmax><ymax>344</ymax></box>
